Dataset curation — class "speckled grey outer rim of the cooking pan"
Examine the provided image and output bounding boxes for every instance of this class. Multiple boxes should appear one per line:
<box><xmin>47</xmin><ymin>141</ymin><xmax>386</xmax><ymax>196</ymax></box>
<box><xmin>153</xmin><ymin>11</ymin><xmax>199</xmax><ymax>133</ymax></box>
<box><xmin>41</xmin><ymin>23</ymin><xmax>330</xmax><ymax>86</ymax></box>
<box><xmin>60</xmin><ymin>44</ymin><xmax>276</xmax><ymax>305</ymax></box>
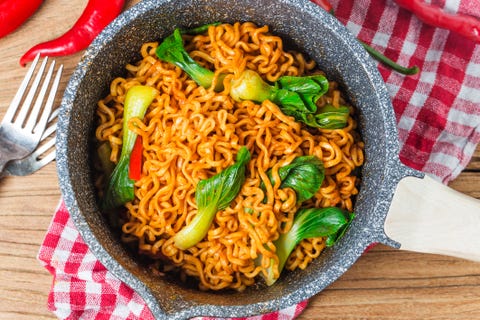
<box><xmin>57</xmin><ymin>0</ymin><xmax>412</xmax><ymax>319</ymax></box>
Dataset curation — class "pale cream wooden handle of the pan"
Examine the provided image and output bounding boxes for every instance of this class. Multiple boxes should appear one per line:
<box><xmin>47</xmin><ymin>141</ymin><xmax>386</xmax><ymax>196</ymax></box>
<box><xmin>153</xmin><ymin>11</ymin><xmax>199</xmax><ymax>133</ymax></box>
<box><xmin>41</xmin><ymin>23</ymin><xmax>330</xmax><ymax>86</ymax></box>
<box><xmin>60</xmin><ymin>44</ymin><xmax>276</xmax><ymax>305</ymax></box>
<box><xmin>385</xmin><ymin>176</ymin><xmax>480</xmax><ymax>261</ymax></box>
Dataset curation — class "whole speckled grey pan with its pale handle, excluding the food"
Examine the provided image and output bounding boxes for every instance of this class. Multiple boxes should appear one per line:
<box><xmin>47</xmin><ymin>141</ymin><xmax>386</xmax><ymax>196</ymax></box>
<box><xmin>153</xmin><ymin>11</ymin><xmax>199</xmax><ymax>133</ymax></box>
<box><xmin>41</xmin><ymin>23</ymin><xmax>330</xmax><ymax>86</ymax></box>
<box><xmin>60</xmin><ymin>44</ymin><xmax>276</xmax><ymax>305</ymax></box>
<box><xmin>57</xmin><ymin>0</ymin><xmax>480</xmax><ymax>319</ymax></box>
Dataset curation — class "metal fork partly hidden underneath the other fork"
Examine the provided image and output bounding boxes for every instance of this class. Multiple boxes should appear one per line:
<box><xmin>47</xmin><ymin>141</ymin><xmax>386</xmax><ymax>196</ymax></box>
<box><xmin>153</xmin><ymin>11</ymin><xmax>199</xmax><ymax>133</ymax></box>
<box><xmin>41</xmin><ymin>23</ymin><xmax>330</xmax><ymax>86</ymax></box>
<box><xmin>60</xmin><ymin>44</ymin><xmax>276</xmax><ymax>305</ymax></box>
<box><xmin>0</xmin><ymin>109</ymin><xmax>59</xmax><ymax>178</ymax></box>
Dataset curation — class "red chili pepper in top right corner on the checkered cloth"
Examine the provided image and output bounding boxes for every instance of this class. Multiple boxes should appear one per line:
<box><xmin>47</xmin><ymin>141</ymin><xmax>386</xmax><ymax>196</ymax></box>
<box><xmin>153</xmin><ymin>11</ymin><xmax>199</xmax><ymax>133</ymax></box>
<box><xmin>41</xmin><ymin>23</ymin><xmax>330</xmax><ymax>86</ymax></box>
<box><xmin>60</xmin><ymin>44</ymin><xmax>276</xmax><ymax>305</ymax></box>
<box><xmin>395</xmin><ymin>0</ymin><xmax>480</xmax><ymax>43</ymax></box>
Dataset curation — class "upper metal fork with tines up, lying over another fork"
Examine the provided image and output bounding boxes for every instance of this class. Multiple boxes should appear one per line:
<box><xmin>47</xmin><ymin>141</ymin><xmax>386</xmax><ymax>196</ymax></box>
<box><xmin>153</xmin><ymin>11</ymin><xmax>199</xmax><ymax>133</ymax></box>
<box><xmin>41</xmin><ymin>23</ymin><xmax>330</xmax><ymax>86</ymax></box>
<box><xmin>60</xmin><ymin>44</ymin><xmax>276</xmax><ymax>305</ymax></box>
<box><xmin>0</xmin><ymin>55</ymin><xmax>63</xmax><ymax>171</ymax></box>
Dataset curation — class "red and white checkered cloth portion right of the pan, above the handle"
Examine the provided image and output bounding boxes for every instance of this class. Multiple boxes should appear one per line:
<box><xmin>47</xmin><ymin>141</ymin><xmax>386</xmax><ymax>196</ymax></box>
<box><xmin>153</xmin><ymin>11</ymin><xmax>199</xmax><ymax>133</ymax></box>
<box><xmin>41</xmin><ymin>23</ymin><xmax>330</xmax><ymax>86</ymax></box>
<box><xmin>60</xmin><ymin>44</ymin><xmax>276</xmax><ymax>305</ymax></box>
<box><xmin>332</xmin><ymin>0</ymin><xmax>480</xmax><ymax>183</ymax></box>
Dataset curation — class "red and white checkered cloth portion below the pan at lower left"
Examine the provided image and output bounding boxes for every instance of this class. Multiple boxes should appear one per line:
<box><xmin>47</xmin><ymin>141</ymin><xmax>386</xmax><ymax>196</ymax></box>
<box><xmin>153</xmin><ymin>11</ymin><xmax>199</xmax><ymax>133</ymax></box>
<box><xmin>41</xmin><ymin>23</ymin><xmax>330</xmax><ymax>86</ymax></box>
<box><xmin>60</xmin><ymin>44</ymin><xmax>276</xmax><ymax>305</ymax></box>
<box><xmin>38</xmin><ymin>201</ymin><xmax>307</xmax><ymax>320</ymax></box>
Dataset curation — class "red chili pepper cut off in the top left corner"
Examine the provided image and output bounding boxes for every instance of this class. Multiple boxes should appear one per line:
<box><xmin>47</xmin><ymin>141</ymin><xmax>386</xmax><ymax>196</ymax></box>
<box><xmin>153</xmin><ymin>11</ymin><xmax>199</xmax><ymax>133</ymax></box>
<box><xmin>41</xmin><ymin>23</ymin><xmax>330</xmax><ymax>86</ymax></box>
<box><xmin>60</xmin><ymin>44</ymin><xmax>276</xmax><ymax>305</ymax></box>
<box><xmin>0</xmin><ymin>0</ymin><xmax>43</xmax><ymax>38</ymax></box>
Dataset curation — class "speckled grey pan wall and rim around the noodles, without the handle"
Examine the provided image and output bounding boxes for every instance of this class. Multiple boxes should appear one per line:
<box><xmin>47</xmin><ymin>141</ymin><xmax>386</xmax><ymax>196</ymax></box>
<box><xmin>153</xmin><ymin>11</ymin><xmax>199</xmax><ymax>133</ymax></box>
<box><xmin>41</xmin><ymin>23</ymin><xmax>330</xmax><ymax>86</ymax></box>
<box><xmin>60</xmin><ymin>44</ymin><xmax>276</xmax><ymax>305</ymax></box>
<box><xmin>57</xmin><ymin>0</ymin><xmax>398</xmax><ymax>319</ymax></box>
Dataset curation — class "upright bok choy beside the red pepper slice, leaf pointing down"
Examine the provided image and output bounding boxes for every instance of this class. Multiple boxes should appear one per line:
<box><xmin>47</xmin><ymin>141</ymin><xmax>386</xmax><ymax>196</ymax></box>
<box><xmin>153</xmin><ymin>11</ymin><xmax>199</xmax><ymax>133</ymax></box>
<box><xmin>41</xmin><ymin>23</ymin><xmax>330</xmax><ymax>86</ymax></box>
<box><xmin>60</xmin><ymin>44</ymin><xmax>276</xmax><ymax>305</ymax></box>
<box><xmin>102</xmin><ymin>85</ymin><xmax>157</xmax><ymax>210</ymax></box>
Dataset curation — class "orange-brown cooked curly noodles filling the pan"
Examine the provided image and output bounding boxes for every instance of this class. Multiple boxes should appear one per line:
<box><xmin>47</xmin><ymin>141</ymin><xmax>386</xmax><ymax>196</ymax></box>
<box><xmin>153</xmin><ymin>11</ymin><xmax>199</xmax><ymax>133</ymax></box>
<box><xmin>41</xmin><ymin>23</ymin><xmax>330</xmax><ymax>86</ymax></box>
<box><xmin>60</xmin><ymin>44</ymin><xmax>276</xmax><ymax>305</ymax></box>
<box><xmin>95</xmin><ymin>22</ymin><xmax>364</xmax><ymax>291</ymax></box>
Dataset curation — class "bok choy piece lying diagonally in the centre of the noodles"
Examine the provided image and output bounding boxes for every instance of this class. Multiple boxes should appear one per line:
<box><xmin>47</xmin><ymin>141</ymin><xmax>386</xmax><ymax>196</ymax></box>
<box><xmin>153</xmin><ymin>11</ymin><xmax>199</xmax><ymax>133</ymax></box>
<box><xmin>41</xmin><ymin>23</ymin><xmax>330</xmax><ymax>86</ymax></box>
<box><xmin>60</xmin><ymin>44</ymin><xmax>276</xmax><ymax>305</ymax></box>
<box><xmin>174</xmin><ymin>147</ymin><xmax>250</xmax><ymax>250</ymax></box>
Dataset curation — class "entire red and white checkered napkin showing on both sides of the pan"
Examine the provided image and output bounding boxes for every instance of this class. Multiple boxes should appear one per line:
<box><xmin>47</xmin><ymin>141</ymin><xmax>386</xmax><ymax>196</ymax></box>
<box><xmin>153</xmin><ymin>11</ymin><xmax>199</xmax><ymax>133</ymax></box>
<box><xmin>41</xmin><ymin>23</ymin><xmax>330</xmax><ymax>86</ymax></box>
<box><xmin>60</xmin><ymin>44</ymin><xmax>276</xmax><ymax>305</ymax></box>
<box><xmin>38</xmin><ymin>0</ymin><xmax>480</xmax><ymax>320</ymax></box>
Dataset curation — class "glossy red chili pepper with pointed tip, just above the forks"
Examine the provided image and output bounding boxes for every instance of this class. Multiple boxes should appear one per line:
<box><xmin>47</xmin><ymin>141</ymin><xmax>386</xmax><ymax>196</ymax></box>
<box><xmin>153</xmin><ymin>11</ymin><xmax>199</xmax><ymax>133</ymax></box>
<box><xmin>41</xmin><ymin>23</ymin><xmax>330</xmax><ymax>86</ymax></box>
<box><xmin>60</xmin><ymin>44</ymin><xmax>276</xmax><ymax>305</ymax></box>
<box><xmin>20</xmin><ymin>0</ymin><xmax>125</xmax><ymax>65</ymax></box>
